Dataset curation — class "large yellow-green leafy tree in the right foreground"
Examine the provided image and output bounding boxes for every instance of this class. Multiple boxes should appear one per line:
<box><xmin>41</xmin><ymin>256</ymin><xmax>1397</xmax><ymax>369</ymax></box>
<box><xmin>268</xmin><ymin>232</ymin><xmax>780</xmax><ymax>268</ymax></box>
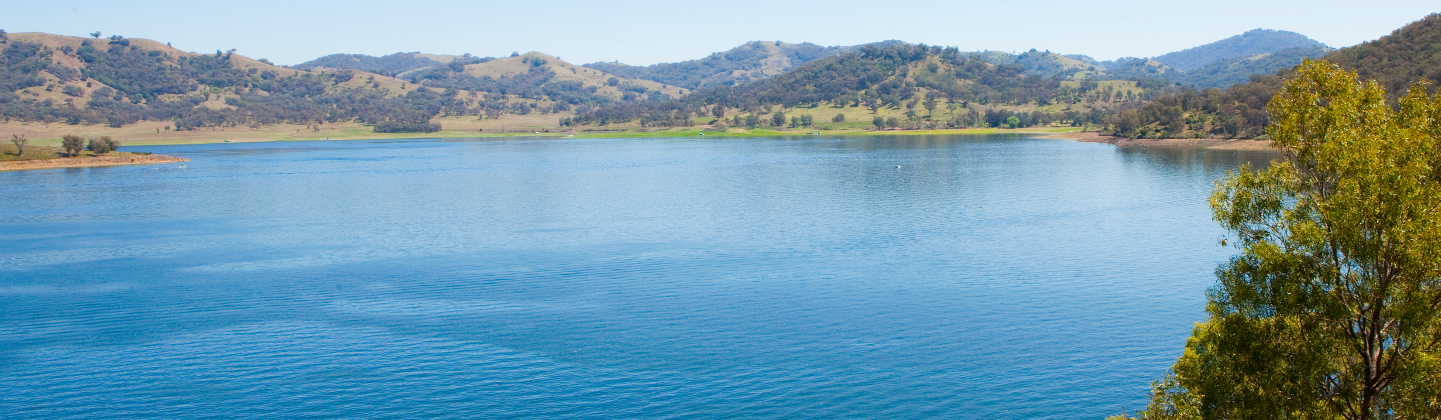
<box><xmin>1123</xmin><ymin>61</ymin><xmax>1441</xmax><ymax>419</ymax></box>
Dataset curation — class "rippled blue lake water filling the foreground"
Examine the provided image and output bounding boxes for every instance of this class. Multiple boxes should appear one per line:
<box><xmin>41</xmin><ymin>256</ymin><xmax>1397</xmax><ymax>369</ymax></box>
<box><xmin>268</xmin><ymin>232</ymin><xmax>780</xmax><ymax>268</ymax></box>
<box><xmin>0</xmin><ymin>136</ymin><xmax>1272</xmax><ymax>419</ymax></box>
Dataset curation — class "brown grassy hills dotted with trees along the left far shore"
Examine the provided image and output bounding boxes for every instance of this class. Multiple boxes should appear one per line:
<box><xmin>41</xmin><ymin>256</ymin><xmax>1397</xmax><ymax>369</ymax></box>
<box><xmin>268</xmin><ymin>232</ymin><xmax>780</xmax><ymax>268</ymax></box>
<box><xmin>0</xmin><ymin>32</ymin><xmax>662</xmax><ymax>133</ymax></box>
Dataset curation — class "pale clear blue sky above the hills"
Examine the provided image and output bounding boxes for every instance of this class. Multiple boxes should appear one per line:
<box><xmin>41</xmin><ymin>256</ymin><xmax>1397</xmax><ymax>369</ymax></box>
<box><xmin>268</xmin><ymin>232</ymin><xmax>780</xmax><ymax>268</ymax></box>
<box><xmin>0</xmin><ymin>0</ymin><xmax>1441</xmax><ymax>65</ymax></box>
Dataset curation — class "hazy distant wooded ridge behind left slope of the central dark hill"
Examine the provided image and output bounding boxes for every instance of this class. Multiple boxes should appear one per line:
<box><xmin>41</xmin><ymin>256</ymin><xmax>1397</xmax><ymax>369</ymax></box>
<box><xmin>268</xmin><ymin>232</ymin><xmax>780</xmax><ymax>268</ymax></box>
<box><xmin>585</xmin><ymin>40</ymin><xmax>885</xmax><ymax>89</ymax></box>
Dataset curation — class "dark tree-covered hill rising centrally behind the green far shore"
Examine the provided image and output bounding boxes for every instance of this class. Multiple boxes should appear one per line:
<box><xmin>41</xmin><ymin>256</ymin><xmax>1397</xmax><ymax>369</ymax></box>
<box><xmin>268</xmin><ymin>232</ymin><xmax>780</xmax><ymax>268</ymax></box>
<box><xmin>566</xmin><ymin>45</ymin><xmax>1170</xmax><ymax>126</ymax></box>
